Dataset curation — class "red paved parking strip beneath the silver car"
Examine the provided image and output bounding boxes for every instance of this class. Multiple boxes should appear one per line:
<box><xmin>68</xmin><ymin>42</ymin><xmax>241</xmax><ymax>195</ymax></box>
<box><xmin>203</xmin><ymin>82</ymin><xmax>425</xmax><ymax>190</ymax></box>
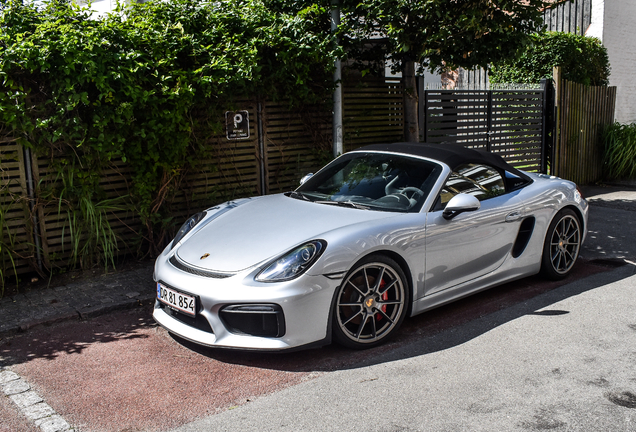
<box><xmin>0</xmin><ymin>262</ymin><xmax>608</xmax><ymax>432</ymax></box>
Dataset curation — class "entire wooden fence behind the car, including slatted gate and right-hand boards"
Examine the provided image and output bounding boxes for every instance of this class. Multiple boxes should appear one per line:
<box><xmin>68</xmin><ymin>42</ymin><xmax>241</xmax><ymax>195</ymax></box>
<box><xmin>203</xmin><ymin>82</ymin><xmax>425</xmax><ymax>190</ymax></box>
<box><xmin>0</xmin><ymin>71</ymin><xmax>616</xmax><ymax>279</ymax></box>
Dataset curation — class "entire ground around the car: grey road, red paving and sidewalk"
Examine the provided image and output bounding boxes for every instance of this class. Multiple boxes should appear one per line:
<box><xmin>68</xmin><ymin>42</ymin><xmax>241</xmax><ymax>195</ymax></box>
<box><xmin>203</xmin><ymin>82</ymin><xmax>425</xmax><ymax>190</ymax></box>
<box><xmin>0</xmin><ymin>185</ymin><xmax>636</xmax><ymax>432</ymax></box>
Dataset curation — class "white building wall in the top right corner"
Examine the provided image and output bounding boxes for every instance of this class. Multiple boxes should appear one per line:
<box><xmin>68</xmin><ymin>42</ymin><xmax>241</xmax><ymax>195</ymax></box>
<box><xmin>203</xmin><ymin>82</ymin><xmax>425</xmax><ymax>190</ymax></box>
<box><xmin>586</xmin><ymin>0</ymin><xmax>636</xmax><ymax>123</ymax></box>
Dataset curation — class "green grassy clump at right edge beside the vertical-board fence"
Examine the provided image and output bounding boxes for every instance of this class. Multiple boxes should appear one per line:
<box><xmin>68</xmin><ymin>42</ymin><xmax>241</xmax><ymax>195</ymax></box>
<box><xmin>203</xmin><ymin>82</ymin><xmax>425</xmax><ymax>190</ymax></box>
<box><xmin>603</xmin><ymin>122</ymin><xmax>636</xmax><ymax>179</ymax></box>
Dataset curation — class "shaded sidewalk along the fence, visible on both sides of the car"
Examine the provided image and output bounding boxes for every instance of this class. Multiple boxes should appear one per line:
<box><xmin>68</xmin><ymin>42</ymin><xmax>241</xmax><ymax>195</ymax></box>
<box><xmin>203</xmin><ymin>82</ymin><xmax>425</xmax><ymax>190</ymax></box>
<box><xmin>0</xmin><ymin>183</ymin><xmax>636</xmax><ymax>338</ymax></box>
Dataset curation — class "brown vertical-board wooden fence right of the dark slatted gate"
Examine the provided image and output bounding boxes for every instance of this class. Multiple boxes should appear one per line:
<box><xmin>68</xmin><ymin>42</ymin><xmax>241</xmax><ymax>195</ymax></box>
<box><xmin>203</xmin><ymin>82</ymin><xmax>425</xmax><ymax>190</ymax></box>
<box><xmin>550</xmin><ymin>68</ymin><xmax>616</xmax><ymax>184</ymax></box>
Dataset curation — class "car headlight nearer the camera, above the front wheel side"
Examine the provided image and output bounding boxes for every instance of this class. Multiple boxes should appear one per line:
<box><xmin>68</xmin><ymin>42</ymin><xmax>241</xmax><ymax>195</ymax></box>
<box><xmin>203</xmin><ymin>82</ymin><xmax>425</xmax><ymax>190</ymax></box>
<box><xmin>256</xmin><ymin>240</ymin><xmax>327</xmax><ymax>282</ymax></box>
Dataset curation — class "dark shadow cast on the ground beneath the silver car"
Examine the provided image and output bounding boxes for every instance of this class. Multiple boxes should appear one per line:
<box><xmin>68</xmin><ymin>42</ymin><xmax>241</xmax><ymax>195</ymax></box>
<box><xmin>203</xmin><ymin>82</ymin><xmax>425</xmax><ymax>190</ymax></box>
<box><xmin>173</xmin><ymin>260</ymin><xmax>624</xmax><ymax>372</ymax></box>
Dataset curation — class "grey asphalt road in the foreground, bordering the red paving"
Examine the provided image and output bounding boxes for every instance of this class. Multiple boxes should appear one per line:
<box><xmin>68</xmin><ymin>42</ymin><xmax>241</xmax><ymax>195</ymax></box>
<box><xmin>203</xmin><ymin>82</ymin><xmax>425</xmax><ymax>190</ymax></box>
<box><xmin>174</xmin><ymin>266</ymin><xmax>636</xmax><ymax>432</ymax></box>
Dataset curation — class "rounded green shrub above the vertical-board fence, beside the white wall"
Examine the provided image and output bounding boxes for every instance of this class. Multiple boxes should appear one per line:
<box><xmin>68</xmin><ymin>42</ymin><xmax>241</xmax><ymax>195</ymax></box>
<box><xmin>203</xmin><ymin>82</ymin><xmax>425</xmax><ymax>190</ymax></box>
<box><xmin>489</xmin><ymin>32</ymin><xmax>610</xmax><ymax>86</ymax></box>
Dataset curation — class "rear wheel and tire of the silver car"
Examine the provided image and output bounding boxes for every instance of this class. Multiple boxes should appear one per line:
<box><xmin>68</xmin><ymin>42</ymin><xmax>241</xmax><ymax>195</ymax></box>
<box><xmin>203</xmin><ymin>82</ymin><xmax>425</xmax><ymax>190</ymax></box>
<box><xmin>541</xmin><ymin>209</ymin><xmax>582</xmax><ymax>280</ymax></box>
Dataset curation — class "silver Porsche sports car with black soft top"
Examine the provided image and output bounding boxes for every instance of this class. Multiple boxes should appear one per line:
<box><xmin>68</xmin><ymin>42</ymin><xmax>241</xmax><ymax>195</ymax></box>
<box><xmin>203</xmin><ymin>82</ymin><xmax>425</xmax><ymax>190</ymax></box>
<box><xmin>153</xmin><ymin>143</ymin><xmax>588</xmax><ymax>351</ymax></box>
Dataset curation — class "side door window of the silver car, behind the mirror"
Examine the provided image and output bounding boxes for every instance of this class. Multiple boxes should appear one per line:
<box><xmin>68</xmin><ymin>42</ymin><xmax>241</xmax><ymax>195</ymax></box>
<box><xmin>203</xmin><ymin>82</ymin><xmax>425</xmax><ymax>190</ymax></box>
<box><xmin>435</xmin><ymin>164</ymin><xmax>506</xmax><ymax>210</ymax></box>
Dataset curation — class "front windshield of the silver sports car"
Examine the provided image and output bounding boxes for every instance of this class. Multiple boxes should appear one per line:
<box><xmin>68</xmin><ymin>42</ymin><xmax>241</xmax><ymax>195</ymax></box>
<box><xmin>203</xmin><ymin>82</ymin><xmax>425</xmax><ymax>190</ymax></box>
<box><xmin>292</xmin><ymin>153</ymin><xmax>442</xmax><ymax>212</ymax></box>
